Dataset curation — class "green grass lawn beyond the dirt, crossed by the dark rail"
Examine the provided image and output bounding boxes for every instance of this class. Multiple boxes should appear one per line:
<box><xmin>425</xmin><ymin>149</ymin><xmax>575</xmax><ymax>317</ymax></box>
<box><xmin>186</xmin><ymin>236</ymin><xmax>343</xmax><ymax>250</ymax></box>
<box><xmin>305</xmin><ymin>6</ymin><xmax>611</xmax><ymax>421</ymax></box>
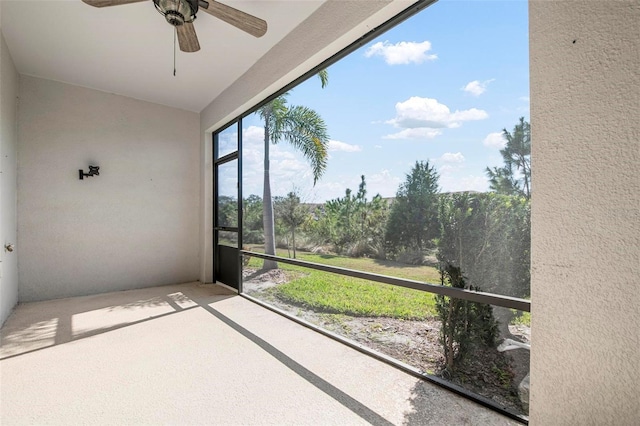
<box><xmin>249</xmin><ymin>246</ymin><xmax>440</xmax><ymax>319</ymax></box>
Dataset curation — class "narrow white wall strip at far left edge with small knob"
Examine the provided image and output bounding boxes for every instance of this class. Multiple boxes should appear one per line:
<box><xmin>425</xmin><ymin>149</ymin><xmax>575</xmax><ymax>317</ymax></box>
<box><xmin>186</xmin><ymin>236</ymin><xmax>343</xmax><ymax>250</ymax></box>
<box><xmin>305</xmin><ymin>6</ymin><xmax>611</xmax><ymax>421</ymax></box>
<box><xmin>0</xmin><ymin>24</ymin><xmax>18</xmax><ymax>325</ymax></box>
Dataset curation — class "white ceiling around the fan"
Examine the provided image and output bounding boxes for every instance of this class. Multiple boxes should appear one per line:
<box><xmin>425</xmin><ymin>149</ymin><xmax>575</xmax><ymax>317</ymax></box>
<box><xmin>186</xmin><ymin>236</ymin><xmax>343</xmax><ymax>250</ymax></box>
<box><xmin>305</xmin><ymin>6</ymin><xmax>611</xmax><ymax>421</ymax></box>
<box><xmin>1</xmin><ymin>0</ymin><xmax>325</xmax><ymax>112</ymax></box>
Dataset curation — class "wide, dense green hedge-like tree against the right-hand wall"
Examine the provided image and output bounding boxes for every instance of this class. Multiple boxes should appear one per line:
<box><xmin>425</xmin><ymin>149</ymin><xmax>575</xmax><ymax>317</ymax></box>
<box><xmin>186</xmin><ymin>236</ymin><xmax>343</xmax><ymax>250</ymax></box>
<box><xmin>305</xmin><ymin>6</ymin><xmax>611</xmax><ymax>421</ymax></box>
<box><xmin>438</xmin><ymin>193</ymin><xmax>531</xmax><ymax>335</ymax></box>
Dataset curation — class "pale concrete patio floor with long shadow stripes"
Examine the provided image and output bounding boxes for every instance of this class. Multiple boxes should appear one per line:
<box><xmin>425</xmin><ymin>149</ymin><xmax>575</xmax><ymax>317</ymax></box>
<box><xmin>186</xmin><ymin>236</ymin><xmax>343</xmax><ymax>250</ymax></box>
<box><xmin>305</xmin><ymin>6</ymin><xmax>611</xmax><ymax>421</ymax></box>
<box><xmin>0</xmin><ymin>283</ymin><xmax>518</xmax><ymax>425</ymax></box>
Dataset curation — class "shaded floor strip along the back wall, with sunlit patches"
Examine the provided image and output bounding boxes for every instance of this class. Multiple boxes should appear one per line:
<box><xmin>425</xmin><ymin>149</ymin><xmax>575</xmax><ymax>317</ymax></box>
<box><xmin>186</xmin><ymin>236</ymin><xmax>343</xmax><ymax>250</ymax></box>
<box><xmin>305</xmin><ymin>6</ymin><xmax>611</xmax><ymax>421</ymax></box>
<box><xmin>0</xmin><ymin>283</ymin><xmax>237</xmax><ymax>360</ymax></box>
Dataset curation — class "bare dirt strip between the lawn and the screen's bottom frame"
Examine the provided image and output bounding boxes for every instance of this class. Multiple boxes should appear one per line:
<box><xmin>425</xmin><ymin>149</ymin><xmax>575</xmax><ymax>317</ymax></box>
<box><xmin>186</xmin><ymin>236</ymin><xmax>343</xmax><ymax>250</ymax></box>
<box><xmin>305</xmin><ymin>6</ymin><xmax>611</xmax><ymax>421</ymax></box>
<box><xmin>243</xmin><ymin>268</ymin><xmax>530</xmax><ymax>414</ymax></box>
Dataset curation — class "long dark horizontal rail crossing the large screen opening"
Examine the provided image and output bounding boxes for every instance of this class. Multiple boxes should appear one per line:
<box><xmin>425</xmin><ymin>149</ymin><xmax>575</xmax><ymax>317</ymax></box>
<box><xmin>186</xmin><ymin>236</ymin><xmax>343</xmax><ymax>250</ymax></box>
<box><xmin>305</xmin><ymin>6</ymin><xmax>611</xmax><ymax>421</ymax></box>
<box><xmin>240</xmin><ymin>250</ymin><xmax>531</xmax><ymax>312</ymax></box>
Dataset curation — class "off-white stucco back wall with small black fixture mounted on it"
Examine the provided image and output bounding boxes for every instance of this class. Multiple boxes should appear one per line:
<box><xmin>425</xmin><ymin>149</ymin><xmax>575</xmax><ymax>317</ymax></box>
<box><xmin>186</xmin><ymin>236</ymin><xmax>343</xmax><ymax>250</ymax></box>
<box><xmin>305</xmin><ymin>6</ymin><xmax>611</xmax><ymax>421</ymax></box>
<box><xmin>18</xmin><ymin>76</ymin><xmax>200</xmax><ymax>301</ymax></box>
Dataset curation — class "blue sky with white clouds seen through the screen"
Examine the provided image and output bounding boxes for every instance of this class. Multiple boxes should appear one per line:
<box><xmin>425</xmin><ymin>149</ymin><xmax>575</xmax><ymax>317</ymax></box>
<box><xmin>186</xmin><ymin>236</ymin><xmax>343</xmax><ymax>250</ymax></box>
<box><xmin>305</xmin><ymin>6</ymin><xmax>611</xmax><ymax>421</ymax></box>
<box><xmin>238</xmin><ymin>0</ymin><xmax>529</xmax><ymax>202</ymax></box>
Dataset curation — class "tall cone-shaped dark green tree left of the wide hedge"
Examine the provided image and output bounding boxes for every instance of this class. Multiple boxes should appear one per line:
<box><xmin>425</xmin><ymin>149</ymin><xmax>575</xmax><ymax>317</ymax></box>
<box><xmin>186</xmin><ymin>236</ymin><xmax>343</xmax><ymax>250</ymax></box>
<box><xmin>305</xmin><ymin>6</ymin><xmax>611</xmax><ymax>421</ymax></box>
<box><xmin>385</xmin><ymin>161</ymin><xmax>439</xmax><ymax>258</ymax></box>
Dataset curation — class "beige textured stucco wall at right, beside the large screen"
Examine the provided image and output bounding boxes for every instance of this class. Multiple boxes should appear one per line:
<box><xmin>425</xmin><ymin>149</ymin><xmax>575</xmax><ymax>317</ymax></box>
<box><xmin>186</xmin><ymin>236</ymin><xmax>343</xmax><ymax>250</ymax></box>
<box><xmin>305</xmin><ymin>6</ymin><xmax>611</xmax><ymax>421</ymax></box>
<box><xmin>530</xmin><ymin>1</ymin><xmax>640</xmax><ymax>425</ymax></box>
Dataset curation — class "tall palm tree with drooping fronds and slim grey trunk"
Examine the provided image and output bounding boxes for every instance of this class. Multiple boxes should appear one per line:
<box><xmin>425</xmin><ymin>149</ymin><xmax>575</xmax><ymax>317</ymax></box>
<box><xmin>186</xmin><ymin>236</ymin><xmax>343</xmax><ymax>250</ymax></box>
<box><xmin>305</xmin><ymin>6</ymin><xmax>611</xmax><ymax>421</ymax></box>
<box><xmin>258</xmin><ymin>70</ymin><xmax>329</xmax><ymax>269</ymax></box>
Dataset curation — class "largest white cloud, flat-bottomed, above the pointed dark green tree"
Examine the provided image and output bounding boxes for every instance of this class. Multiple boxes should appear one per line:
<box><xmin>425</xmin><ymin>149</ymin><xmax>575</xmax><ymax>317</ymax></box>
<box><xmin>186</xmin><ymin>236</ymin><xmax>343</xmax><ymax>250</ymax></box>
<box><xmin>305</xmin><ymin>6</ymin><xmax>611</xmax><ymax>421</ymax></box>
<box><xmin>385</xmin><ymin>96</ymin><xmax>489</xmax><ymax>139</ymax></box>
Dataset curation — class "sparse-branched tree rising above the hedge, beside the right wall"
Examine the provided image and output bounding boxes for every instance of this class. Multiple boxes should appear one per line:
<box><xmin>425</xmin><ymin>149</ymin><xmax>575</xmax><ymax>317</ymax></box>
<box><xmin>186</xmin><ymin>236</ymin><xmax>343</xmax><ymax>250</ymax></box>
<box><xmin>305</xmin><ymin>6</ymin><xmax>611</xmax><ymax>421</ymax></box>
<box><xmin>485</xmin><ymin>117</ymin><xmax>531</xmax><ymax>199</ymax></box>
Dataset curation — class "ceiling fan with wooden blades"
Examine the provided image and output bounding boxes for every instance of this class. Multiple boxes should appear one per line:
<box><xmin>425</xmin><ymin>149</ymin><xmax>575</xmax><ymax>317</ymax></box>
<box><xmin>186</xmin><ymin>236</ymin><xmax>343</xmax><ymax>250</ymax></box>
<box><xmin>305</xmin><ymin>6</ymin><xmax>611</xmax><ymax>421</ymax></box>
<box><xmin>82</xmin><ymin>0</ymin><xmax>267</xmax><ymax>52</ymax></box>
